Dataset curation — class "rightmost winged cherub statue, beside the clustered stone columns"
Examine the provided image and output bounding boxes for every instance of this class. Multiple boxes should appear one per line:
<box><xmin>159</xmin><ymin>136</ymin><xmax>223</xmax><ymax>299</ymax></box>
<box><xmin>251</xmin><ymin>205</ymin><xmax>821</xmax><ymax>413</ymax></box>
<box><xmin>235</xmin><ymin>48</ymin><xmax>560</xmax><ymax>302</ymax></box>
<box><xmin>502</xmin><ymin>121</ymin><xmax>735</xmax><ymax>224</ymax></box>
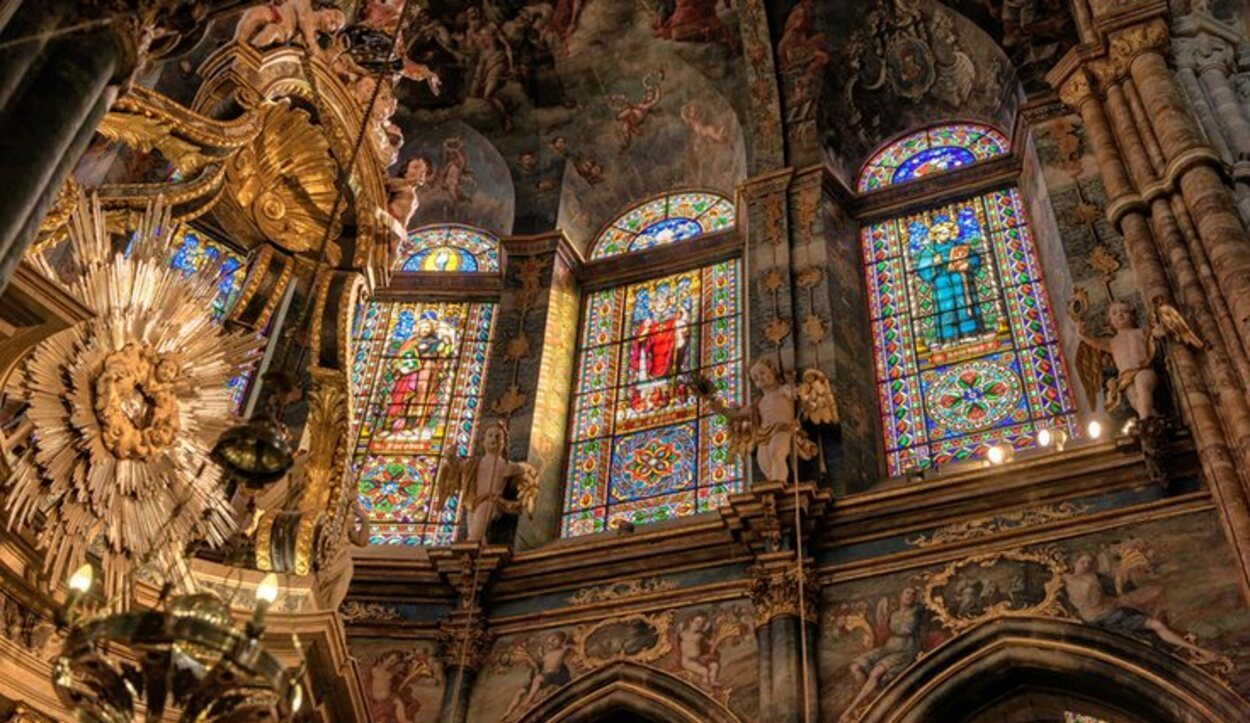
<box><xmin>1076</xmin><ymin>296</ymin><xmax>1203</xmax><ymax>419</ymax></box>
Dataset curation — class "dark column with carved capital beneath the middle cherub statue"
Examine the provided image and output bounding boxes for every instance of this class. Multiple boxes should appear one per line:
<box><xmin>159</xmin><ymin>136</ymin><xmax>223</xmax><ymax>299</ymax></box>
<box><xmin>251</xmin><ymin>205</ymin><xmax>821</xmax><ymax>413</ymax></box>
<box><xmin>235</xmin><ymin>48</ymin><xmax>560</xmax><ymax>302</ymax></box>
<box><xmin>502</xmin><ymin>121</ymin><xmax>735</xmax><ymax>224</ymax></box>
<box><xmin>720</xmin><ymin>482</ymin><xmax>833</xmax><ymax>723</ymax></box>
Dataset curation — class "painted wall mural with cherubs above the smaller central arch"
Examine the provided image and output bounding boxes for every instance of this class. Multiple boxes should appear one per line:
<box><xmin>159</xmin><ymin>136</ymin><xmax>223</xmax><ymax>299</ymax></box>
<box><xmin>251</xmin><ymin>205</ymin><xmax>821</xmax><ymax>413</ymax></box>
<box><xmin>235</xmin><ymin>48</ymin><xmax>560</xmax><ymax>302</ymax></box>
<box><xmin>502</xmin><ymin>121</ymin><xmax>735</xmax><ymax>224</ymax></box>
<box><xmin>469</xmin><ymin>602</ymin><xmax>759</xmax><ymax>722</ymax></box>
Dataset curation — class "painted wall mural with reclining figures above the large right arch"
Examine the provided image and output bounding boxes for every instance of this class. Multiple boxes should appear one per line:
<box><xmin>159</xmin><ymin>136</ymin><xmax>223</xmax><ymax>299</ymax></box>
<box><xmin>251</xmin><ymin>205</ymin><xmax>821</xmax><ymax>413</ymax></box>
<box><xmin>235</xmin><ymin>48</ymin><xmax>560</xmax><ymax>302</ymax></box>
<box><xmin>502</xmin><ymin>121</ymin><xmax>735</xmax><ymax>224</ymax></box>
<box><xmin>819</xmin><ymin>512</ymin><xmax>1250</xmax><ymax>720</ymax></box>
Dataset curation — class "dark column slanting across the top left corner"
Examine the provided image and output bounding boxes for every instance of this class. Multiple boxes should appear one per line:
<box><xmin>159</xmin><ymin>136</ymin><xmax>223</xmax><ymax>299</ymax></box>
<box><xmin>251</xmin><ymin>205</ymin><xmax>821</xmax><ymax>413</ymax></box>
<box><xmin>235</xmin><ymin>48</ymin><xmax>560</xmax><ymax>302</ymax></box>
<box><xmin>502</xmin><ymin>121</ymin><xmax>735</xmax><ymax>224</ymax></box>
<box><xmin>0</xmin><ymin>0</ymin><xmax>214</xmax><ymax>288</ymax></box>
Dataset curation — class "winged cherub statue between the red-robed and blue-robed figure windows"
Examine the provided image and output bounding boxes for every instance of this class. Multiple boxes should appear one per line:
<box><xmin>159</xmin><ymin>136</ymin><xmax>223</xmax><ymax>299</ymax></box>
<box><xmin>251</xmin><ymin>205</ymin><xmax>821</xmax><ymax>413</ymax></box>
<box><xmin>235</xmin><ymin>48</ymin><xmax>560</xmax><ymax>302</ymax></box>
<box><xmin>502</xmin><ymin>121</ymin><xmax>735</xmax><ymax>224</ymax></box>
<box><xmin>695</xmin><ymin>356</ymin><xmax>838</xmax><ymax>482</ymax></box>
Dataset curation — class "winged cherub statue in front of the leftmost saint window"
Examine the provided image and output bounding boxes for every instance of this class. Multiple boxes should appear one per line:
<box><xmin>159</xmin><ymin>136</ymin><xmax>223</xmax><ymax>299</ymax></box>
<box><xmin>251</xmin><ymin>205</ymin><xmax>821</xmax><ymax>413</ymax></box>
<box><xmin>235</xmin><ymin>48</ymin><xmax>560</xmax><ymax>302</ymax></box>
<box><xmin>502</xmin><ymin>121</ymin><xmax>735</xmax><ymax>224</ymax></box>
<box><xmin>434</xmin><ymin>422</ymin><xmax>539</xmax><ymax>543</ymax></box>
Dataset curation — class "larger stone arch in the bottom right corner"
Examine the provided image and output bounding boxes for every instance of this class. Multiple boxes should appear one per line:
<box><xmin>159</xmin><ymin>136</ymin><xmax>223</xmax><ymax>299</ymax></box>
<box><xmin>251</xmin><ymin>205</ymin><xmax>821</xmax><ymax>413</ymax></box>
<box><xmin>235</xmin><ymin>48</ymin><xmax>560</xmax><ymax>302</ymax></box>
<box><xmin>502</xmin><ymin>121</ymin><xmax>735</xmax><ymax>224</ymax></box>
<box><xmin>860</xmin><ymin>618</ymin><xmax>1250</xmax><ymax>723</ymax></box>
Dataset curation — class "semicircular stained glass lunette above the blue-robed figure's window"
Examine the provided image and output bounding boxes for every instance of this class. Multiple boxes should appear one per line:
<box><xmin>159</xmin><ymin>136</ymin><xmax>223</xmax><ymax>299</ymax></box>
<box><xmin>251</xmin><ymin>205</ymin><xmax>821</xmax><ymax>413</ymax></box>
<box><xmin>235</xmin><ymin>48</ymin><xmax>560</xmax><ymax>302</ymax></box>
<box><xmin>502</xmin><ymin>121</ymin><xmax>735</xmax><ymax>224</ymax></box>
<box><xmin>858</xmin><ymin>123</ymin><xmax>1010</xmax><ymax>193</ymax></box>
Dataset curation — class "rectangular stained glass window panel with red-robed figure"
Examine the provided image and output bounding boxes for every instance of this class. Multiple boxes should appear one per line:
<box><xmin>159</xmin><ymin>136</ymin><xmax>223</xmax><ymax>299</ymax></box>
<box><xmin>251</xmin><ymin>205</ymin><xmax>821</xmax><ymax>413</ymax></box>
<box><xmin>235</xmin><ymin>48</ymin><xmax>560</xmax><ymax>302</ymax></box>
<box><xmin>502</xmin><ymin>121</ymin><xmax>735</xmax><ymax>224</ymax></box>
<box><xmin>563</xmin><ymin>260</ymin><xmax>744</xmax><ymax>537</ymax></box>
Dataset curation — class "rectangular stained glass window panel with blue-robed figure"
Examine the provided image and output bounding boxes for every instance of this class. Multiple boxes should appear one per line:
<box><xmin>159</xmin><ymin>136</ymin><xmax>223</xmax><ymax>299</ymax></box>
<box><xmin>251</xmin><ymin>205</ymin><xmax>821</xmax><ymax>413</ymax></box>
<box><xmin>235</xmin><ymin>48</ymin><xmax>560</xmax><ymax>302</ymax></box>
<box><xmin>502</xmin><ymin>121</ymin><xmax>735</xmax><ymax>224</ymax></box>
<box><xmin>861</xmin><ymin>189</ymin><xmax>1075</xmax><ymax>475</ymax></box>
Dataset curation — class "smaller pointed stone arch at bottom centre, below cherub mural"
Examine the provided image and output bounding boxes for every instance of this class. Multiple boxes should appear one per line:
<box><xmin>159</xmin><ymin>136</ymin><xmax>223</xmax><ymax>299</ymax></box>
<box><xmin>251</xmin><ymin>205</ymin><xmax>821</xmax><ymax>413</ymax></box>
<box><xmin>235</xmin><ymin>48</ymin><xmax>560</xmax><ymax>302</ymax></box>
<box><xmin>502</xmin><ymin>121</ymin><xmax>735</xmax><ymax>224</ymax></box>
<box><xmin>518</xmin><ymin>660</ymin><xmax>741</xmax><ymax>723</ymax></box>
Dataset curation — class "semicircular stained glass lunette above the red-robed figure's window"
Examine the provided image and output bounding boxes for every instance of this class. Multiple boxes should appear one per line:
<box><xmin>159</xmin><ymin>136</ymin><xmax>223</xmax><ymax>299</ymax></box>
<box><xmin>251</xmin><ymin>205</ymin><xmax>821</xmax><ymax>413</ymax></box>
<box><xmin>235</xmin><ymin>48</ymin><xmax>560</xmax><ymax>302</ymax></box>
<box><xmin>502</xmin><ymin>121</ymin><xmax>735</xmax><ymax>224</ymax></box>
<box><xmin>590</xmin><ymin>191</ymin><xmax>734</xmax><ymax>259</ymax></box>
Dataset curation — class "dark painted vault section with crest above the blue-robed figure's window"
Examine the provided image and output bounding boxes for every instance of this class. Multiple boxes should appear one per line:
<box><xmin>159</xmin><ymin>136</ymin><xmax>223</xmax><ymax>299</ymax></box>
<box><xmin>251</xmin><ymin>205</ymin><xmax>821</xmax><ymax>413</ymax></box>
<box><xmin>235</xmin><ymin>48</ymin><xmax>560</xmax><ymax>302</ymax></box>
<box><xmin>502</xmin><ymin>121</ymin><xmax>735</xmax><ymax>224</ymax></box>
<box><xmin>773</xmin><ymin>0</ymin><xmax>1018</xmax><ymax>181</ymax></box>
